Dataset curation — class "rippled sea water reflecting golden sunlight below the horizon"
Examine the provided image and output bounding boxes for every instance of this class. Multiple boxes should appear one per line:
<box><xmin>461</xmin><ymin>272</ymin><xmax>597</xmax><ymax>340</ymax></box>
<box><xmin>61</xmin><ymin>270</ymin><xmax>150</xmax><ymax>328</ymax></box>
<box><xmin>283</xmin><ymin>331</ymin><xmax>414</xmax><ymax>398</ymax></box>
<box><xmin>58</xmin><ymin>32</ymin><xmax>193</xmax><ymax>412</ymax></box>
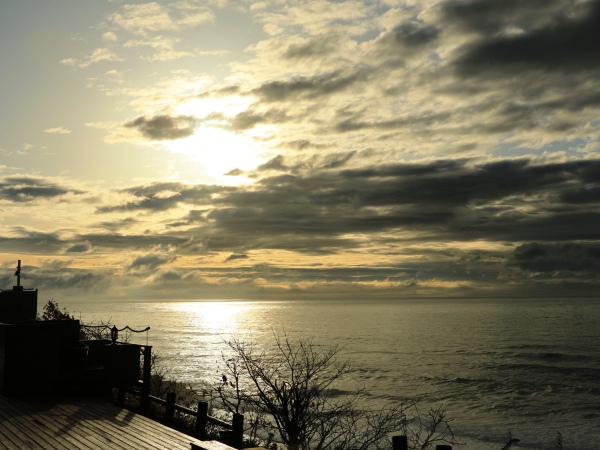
<box><xmin>60</xmin><ymin>298</ymin><xmax>600</xmax><ymax>450</ymax></box>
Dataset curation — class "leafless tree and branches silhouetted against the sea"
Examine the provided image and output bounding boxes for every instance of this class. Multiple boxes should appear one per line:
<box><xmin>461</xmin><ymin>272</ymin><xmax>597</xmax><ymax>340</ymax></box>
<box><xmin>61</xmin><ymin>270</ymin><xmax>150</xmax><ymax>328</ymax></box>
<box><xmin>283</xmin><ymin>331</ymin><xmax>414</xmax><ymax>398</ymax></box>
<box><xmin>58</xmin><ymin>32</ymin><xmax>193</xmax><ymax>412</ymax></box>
<box><xmin>214</xmin><ymin>334</ymin><xmax>456</xmax><ymax>450</ymax></box>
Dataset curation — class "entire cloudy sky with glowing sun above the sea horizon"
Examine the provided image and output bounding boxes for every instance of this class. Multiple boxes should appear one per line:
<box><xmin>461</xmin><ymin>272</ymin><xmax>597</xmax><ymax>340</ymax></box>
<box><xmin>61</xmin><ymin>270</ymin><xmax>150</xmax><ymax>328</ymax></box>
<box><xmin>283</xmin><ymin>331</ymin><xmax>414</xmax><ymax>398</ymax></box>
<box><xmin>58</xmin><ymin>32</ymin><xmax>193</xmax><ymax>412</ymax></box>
<box><xmin>0</xmin><ymin>0</ymin><xmax>600</xmax><ymax>303</ymax></box>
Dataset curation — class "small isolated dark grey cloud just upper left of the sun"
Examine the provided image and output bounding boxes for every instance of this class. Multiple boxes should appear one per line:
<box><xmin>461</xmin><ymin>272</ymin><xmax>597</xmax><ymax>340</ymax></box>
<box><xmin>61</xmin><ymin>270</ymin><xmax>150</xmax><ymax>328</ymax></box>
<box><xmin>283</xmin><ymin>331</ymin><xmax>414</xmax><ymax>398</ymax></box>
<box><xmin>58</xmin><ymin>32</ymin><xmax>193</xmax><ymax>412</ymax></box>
<box><xmin>123</xmin><ymin>115</ymin><xmax>196</xmax><ymax>141</ymax></box>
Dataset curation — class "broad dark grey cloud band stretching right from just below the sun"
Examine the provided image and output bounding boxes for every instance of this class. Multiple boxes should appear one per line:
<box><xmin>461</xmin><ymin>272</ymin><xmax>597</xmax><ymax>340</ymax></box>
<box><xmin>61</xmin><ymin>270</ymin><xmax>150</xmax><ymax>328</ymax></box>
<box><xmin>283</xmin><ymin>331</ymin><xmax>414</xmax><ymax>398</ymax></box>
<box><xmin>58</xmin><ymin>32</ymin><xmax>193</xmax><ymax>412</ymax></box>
<box><xmin>88</xmin><ymin>157</ymin><xmax>600</xmax><ymax>254</ymax></box>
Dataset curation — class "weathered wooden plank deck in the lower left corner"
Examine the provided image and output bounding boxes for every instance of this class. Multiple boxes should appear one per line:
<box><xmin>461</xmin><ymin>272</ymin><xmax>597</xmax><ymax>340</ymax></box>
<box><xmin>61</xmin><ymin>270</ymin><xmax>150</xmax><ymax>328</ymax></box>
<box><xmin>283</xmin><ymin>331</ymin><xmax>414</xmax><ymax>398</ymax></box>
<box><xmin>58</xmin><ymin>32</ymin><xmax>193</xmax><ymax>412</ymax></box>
<box><xmin>0</xmin><ymin>395</ymin><xmax>217</xmax><ymax>450</ymax></box>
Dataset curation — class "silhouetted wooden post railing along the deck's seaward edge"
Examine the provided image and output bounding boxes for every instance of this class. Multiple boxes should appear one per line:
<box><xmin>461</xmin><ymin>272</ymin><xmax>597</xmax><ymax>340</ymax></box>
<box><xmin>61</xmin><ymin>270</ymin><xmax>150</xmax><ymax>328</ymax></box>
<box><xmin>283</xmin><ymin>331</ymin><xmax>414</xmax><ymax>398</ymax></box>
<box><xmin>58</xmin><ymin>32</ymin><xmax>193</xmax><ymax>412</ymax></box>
<box><xmin>117</xmin><ymin>345</ymin><xmax>244</xmax><ymax>448</ymax></box>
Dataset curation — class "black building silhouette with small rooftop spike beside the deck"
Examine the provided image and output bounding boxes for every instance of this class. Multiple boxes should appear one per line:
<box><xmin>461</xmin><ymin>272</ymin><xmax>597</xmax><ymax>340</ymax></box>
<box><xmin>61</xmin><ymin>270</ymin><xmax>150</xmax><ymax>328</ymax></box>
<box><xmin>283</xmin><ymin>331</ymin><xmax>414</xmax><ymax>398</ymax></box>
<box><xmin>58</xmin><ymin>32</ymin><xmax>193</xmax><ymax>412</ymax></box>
<box><xmin>0</xmin><ymin>260</ymin><xmax>140</xmax><ymax>395</ymax></box>
